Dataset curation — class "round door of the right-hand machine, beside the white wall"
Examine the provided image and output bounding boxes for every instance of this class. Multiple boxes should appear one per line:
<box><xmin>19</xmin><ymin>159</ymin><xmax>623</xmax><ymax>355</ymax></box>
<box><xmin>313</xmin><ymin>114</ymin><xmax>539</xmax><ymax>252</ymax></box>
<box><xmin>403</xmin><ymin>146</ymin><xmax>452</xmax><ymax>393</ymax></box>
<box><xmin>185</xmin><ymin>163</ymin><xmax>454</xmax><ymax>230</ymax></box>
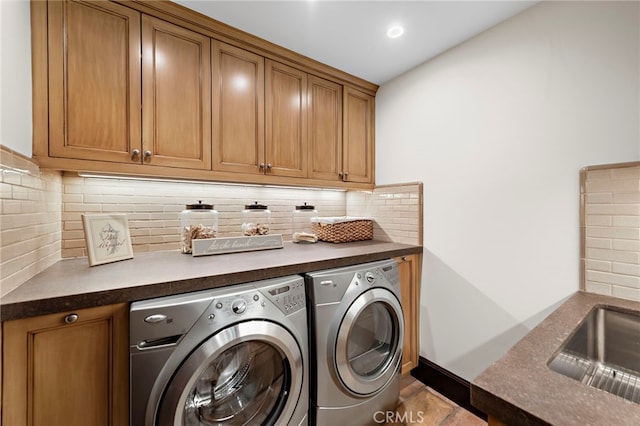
<box><xmin>335</xmin><ymin>288</ymin><xmax>404</xmax><ymax>395</ymax></box>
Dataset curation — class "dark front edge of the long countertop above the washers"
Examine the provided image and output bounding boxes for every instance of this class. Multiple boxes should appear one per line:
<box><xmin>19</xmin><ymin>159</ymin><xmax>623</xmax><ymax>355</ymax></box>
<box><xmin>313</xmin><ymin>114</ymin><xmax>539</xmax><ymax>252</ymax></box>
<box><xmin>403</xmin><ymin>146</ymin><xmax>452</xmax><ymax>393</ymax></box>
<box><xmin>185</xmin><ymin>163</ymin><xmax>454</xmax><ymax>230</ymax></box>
<box><xmin>0</xmin><ymin>245</ymin><xmax>423</xmax><ymax>322</ymax></box>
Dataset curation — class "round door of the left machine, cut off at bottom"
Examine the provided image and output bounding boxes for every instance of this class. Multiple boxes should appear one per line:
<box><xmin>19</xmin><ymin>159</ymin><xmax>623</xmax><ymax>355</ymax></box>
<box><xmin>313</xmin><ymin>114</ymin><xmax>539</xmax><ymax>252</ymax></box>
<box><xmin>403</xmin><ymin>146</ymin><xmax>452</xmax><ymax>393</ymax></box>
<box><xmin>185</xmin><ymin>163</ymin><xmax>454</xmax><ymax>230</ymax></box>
<box><xmin>156</xmin><ymin>320</ymin><xmax>304</xmax><ymax>426</ymax></box>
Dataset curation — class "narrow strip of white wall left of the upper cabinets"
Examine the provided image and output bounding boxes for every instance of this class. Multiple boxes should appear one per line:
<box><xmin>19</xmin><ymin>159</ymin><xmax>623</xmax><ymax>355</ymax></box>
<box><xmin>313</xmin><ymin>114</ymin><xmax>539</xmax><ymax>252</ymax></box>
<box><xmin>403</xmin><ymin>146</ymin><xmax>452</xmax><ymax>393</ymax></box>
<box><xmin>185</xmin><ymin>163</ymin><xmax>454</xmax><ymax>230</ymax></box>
<box><xmin>0</xmin><ymin>0</ymin><xmax>33</xmax><ymax>157</ymax></box>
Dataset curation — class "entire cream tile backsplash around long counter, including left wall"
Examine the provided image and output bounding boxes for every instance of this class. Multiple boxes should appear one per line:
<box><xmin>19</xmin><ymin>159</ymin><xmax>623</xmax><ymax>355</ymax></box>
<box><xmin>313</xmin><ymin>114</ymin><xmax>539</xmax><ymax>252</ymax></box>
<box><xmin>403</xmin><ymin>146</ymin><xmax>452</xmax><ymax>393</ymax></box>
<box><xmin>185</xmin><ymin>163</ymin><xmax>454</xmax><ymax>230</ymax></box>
<box><xmin>0</xmin><ymin>146</ymin><xmax>422</xmax><ymax>296</ymax></box>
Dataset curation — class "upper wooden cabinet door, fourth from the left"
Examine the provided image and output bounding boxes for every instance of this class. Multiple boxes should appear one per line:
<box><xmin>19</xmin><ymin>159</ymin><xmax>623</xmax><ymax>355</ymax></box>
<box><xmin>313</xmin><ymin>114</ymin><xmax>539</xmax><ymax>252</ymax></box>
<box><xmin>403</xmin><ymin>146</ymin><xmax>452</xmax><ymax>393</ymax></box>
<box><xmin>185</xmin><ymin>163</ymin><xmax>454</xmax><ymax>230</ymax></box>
<box><xmin>265</xmin><ymin>60</ymin><xmax>307</xmax><ymax>177</ymax></box>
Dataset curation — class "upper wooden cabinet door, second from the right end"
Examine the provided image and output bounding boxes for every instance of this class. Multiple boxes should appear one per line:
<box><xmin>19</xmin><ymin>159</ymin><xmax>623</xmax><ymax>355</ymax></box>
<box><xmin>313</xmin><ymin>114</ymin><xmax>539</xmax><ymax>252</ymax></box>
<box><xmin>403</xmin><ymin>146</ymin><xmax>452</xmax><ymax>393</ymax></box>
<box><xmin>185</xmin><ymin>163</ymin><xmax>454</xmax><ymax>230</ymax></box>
<box><xmin>307</xmin><ymin>75</ymin><xmax>342</xmax><ymax>181</ymax></box>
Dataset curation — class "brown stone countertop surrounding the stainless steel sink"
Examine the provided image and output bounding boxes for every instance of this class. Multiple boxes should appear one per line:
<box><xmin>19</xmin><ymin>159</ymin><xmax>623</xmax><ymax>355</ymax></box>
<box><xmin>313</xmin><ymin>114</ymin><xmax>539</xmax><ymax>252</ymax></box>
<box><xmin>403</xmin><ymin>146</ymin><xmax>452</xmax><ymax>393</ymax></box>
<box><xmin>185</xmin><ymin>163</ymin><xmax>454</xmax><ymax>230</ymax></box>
<box><xmin>471</xmin><ymin>292</ymin><xmax>640</xmax><ymax>426</ymax></box>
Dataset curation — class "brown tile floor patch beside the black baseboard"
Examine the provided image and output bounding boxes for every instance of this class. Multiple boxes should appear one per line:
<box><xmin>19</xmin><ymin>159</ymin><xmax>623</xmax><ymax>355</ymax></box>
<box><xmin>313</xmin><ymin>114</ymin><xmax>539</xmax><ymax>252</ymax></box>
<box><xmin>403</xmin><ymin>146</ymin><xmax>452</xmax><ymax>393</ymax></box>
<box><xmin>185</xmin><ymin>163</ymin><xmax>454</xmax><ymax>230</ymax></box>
<box><xmin>386</xmin><ymin>375</ymin><xmax>487</xmax><ymax>426</ymax></box>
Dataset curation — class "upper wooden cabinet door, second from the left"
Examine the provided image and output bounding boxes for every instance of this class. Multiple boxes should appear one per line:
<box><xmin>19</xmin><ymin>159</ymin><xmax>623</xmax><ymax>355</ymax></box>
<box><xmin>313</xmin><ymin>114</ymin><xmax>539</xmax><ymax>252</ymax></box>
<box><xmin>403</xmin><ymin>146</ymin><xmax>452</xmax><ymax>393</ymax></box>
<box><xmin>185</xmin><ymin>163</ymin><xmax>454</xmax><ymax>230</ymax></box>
<box><xmin>142</xmin><ymin>15</ymin><xmax>211</xmax><ymax>170</ymax></box>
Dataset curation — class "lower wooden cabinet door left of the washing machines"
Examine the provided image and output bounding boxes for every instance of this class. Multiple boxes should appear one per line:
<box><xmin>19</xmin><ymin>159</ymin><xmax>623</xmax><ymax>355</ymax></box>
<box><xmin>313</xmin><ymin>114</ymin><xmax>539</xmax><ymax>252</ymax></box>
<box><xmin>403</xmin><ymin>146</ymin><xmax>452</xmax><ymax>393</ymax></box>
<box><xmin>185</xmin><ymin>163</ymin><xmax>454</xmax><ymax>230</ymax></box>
<box><xmin>2</xmin><ymin>304</ymin><xmax>129</xmax><ymax>426</ymax></box>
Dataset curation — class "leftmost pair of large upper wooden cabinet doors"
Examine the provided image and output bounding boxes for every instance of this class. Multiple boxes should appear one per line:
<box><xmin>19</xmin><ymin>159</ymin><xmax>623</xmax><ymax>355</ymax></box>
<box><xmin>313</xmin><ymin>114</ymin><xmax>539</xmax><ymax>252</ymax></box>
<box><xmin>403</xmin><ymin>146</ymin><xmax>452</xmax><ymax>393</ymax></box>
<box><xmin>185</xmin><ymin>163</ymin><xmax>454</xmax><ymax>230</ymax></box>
<box><xmin>42</xmin><ymin>1</ymin><xmax>211</xmax><ymax>169</ymax></box>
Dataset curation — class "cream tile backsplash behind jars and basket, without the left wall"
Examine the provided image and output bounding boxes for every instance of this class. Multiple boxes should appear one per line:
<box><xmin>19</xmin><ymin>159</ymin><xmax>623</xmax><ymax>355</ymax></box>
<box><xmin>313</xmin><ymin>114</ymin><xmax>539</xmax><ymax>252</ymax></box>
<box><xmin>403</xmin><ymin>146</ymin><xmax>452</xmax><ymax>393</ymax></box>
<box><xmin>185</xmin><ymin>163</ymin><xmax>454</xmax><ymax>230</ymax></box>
<box><xmin>62</xmin><ymin>174</ymin><xmax>422</xmax><ymax>257</ymax></box>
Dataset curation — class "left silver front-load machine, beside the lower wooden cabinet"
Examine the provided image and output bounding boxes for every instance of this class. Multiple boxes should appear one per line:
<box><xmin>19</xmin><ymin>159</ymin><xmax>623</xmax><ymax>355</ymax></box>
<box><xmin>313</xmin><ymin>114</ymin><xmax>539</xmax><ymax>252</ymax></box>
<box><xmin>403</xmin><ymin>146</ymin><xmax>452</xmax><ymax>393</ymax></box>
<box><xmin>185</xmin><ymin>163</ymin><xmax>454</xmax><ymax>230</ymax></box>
<box><xmin>130</xmin><ymin>276</ymin><xmax>309</xmax><ymax>426</ymax></box>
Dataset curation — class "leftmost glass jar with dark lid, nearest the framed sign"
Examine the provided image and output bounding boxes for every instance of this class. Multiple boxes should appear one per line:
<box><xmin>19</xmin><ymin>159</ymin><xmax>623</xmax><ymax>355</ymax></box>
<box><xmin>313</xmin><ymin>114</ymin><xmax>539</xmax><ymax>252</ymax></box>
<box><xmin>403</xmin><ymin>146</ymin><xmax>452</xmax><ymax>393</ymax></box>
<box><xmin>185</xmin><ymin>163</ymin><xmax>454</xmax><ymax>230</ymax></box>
<box><xmin>180</xmin><ymin>200</ymin><xmax>218</xmax><ymax>254</ymax></box>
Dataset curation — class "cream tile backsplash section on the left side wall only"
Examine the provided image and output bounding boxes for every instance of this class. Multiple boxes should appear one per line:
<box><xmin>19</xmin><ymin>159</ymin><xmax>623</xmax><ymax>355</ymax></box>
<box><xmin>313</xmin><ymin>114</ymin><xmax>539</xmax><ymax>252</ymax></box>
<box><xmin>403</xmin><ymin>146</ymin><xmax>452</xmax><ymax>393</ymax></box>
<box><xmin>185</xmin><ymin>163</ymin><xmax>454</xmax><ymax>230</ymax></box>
<box><xmin>0</xmin><ymin>148</ymin><xmax>62</xmax><ymax>296</ymax></box>
